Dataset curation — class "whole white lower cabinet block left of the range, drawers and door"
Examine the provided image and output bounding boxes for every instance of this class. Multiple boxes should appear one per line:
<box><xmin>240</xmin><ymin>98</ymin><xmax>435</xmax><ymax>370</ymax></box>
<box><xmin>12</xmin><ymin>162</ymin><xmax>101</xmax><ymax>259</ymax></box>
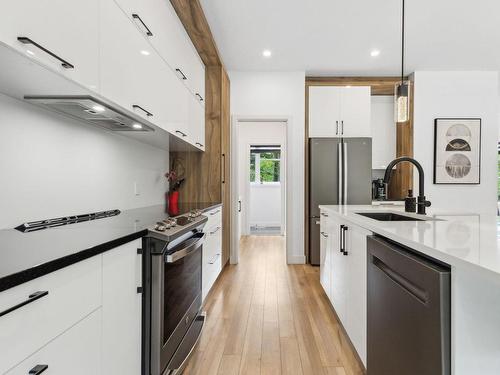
<box><xmin>0</xmin><ymin>239</ymin><xmax>142</xmax><ymax>375</ymax></box>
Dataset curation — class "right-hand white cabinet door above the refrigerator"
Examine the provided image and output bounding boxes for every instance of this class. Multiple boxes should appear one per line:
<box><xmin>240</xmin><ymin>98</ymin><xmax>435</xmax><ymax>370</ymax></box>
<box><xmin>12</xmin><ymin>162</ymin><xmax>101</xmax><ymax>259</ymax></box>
<box><xmin>340</xmin><ymin>86</ymin><xmax>371</xmax><ymax>137</ymax></box>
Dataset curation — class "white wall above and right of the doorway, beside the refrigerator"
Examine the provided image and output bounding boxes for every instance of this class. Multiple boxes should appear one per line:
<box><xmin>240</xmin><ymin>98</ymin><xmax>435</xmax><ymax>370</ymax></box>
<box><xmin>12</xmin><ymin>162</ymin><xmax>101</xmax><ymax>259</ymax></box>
<box><xmin>229</xmin><ymin>71</ymin><xmax>305</xmax><ymax>263</ymax></box>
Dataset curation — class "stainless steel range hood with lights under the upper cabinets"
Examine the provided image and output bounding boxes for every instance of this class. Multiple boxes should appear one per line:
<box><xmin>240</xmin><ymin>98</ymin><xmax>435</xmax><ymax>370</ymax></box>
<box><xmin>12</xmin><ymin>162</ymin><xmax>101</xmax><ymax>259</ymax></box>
<box><xmin>24</xmin><ymin>96</ymin><xmax>154</xmax><ymax>132</ymax></box>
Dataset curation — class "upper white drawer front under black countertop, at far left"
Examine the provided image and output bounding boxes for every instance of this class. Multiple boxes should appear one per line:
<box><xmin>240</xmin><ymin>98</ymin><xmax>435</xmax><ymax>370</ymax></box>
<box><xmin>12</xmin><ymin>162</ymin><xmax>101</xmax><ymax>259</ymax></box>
<box><xmin>0</xmin><ymin>255</ymin><xmax>102</xmax><ymax>373</ymax></box>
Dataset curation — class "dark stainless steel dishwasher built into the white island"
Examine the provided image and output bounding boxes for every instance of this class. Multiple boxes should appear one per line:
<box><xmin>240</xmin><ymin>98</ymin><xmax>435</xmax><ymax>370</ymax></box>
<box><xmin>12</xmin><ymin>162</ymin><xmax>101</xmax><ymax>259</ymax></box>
<box><xmin>367</xmin><ymin>236</ymin><xmax>451</xmax><ymax>375</ymax></box>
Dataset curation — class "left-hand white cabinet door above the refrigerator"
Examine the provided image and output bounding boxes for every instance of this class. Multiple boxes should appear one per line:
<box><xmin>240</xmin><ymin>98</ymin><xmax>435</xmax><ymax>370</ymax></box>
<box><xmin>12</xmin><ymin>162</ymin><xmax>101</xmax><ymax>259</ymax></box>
<box><xmin>309</xmin><ymin>86</ymin><xmax>342</xmax><ymax>138</ymax></box>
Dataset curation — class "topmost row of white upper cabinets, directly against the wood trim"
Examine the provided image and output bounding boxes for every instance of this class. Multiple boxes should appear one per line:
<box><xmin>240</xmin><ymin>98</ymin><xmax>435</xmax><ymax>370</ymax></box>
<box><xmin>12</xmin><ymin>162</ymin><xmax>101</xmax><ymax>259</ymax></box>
<box><xmin>116</xmin><ymin>0</ymin><xmax>205</xmax><ymax>103</ymax></box>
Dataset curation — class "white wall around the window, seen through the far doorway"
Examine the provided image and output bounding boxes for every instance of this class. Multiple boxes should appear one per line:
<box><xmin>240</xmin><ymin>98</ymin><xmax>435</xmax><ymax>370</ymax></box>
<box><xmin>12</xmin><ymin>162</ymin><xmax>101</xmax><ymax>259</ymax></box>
<box><xmin>236</xmin><ymin>121</ymin><xmax>287</xmax><ymax>234</ymax></box>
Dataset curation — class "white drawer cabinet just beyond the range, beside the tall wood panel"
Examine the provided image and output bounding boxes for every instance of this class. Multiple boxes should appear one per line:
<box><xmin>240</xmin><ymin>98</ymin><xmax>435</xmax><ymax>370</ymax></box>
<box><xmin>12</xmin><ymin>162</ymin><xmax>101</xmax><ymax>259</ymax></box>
<box><xmin>202</xmin><ymin>207</ymin><xmax>222</xmax><ymax>299</ymax></box>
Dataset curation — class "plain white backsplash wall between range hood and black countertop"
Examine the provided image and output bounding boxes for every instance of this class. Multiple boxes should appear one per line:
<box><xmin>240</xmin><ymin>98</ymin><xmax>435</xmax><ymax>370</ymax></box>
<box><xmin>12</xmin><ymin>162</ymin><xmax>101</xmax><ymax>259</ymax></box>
<box><xmin>0</xmin><ymin>95</ymin><xmax>168</xmax><ymax>228</ymax></box>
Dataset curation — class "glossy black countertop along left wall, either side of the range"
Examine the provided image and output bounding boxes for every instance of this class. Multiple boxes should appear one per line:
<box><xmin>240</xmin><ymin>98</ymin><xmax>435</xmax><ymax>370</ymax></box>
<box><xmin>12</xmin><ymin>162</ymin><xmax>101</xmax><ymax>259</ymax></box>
<box><xmin>0</xmin><ymin>202</ymin><xmax>221</xmax><ymax>292</ymax></box>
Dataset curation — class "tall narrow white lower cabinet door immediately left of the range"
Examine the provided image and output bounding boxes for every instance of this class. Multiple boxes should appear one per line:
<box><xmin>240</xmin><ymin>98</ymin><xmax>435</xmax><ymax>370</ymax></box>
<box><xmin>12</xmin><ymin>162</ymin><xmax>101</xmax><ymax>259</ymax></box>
<box><xmin>102</xmin><ymin>240</ymin><xmax>142</xmax><ymax>375</ymax></box>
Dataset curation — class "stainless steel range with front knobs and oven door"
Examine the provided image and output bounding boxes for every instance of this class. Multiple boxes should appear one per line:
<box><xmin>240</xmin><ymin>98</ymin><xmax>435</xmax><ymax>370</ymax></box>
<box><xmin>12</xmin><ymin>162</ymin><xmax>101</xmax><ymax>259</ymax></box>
<box><xmin>143</xmin><ymin>211</ymin><xmax>207</xmax><ymax>375</ymax></box>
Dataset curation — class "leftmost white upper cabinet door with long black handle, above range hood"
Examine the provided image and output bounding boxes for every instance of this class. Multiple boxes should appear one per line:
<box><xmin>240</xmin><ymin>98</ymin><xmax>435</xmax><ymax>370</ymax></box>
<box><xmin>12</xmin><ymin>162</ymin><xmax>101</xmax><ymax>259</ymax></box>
<box><xmin>0</xmin><ymin>0</ymin><xmax>99</xmax><ymax>91</ymax></box>
